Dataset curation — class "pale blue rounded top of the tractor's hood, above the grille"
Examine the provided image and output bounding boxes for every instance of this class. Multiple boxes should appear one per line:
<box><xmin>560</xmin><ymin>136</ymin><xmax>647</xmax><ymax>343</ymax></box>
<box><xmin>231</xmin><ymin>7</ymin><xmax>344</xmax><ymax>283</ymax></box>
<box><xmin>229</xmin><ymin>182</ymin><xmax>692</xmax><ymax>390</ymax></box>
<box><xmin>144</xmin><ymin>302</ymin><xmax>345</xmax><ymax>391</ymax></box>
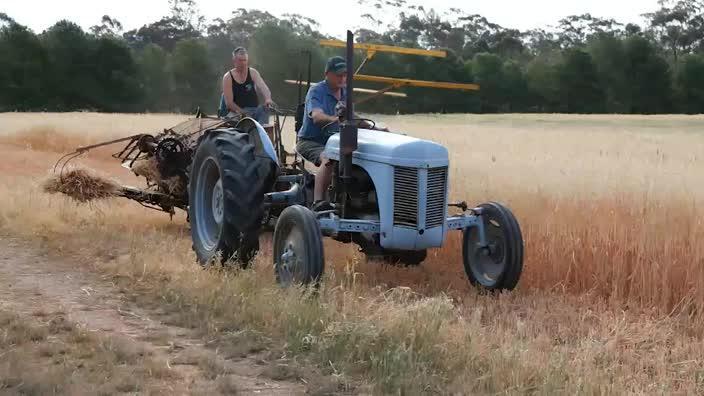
<box><xmin>324</xmin><ymin>129</ymin><xmax>449</xmax><ymax>168</ymax></box>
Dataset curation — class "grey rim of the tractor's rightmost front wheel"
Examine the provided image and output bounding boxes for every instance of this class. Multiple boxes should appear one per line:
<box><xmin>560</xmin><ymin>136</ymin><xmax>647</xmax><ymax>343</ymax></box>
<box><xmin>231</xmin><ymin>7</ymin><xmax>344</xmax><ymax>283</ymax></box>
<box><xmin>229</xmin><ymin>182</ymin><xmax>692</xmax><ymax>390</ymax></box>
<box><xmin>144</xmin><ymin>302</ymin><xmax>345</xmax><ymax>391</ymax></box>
<box><xmin>467</xmin><ymin>218</ymin><xmax>508</xmax><ymax>287</ymax></box>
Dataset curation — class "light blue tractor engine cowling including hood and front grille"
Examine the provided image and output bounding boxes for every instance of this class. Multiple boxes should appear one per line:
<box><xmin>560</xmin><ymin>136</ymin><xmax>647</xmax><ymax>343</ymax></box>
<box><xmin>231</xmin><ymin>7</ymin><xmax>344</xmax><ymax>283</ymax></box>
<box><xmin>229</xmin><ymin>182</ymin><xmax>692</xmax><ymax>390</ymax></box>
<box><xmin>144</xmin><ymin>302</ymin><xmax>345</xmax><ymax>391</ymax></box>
<box><xmin>325</xmin><ymin>129</ymin><xmax>449</xmax><ymax>250</ymax></box>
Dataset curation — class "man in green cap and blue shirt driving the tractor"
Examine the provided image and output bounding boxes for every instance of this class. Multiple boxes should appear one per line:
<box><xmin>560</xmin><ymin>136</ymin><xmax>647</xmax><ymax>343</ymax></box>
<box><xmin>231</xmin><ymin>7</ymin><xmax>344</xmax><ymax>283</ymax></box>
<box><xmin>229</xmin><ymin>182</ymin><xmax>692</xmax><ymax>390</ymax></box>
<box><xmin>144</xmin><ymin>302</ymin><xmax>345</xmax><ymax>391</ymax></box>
<box><xmin>296</xmin><ymin>56</ymin><xmax>388</xmax><ymax>211</ymax></box>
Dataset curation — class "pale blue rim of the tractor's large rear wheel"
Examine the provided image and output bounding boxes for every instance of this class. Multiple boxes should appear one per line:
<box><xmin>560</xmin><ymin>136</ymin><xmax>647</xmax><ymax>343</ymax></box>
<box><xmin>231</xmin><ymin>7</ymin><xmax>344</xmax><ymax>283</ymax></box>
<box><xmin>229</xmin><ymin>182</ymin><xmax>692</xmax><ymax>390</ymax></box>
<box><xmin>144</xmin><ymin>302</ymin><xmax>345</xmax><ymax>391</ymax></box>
<box><xmin>193</xmin><ymin>158</ymin><xmax>225</xmax><ymax>251</ymax></box>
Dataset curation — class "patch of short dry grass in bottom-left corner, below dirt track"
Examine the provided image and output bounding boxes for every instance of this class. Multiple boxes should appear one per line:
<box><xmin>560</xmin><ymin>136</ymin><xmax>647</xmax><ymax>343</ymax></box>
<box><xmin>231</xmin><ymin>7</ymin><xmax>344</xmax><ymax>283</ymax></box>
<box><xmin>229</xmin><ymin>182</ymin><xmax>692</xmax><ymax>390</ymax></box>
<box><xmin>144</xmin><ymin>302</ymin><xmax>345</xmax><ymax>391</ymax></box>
<box><xmin>0</xmin><ymin>311</ymin><xmax>180</xmax><ymax>395</ymax></box>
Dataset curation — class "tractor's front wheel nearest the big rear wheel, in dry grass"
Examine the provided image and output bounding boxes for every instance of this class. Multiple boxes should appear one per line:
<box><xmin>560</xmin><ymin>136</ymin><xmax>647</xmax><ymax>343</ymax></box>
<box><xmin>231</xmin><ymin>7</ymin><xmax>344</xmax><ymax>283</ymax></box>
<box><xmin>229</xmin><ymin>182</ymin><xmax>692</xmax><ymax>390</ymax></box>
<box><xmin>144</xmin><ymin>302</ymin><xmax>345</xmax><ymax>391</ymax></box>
<box><xmin>272</xmin><ymin>205</ymin><xmax>325</xmax><ymax>287</ymax></box>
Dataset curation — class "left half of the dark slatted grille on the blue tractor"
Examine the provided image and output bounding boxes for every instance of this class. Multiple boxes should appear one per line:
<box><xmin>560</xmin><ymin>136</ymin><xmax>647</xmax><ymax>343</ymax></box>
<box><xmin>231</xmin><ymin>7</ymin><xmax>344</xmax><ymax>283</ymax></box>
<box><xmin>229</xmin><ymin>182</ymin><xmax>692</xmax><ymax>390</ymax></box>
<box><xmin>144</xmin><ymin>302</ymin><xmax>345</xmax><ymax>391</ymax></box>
<box><xmin>394</xmin><ymin>167</ymin><xmax>418</xmax><ymax>227</ymax></box>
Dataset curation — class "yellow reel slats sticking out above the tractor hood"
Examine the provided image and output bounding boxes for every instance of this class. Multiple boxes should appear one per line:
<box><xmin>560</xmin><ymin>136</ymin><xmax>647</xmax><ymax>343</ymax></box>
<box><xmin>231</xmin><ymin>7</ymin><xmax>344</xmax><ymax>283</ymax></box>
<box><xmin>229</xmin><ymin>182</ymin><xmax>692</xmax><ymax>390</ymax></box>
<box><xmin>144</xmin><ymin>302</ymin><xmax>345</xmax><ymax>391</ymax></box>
<box><xmin>319</xmin><ymin>40</ymin><xmax>479</xmax><ymax>104</ymax></box>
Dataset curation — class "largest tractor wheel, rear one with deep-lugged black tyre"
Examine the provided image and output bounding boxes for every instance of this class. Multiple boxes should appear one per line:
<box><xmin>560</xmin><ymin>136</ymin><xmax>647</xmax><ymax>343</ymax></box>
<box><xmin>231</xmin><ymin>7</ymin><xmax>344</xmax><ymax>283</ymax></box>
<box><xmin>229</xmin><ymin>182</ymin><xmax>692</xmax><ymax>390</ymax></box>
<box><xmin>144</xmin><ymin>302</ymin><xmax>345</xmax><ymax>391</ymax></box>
<box><xmin>188</xmin><ymin>131</ymin><xmax>274</xmax><ymax>267</ymax></box>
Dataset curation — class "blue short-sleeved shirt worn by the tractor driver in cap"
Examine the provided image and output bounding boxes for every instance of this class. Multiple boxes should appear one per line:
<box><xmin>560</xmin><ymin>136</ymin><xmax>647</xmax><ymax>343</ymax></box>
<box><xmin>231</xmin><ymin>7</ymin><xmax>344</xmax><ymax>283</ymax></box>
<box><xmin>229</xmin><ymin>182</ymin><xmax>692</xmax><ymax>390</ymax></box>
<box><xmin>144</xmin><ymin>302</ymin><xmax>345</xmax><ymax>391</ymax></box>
<box><xmin>298</xmin><ymin>80</ymin><xmax>347</xmax><ymax>144</ymax></box>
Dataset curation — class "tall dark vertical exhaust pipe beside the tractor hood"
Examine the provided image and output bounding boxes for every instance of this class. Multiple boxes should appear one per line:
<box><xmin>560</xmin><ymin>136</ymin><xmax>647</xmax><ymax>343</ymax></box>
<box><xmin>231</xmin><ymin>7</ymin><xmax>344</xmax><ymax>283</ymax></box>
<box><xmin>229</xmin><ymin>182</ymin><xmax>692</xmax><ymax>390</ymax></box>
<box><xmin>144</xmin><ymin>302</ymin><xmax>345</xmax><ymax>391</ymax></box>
<box><xmin>340</xmin><ymin>30</ymin><xmax>358</xmax><ymax>218</ymax></box>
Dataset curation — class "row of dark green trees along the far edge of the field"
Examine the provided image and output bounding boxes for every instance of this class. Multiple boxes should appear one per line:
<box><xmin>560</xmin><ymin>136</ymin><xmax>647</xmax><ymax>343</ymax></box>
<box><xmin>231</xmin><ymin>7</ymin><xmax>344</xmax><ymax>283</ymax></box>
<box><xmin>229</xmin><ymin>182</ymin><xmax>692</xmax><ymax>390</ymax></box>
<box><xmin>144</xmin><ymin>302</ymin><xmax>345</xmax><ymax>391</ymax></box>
<box><xmin>0</xmin><ymin>0</ymin><xmax>704</xmax><ymax>114</ymax></box>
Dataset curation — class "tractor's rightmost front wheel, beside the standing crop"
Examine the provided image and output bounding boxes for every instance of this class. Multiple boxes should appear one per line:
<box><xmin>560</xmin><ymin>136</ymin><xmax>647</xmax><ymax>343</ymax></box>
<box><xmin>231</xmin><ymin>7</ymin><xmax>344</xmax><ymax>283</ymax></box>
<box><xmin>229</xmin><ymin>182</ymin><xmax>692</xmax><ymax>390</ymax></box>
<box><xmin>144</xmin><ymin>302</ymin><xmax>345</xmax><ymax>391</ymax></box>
<box><xmin>462</xmin><ymin>202</ymin><xmax>523</xmax><ymax>291</ymax></box>
